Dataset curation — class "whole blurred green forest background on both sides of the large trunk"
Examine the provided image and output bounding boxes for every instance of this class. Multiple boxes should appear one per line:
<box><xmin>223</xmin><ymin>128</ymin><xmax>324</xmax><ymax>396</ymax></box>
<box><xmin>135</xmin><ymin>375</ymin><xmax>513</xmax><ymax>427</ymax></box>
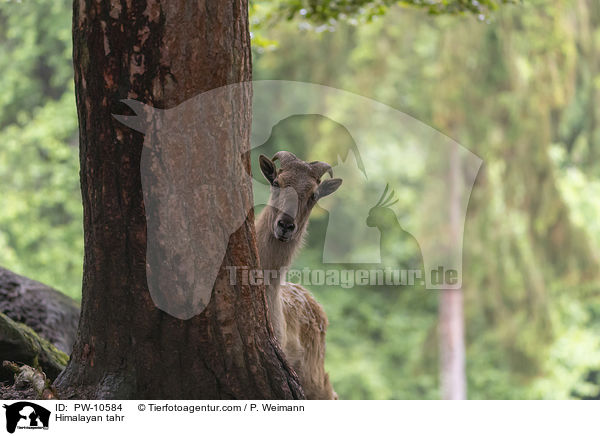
<box><xmin>0</xmin><ymin>0</ymin><xmax>600</xmax><ymax>399</ymax></box>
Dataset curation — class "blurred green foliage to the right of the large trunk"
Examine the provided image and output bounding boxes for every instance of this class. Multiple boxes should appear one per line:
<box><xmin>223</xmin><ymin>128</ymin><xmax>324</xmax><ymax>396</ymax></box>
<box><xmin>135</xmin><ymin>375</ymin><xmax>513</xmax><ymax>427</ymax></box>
<box><xmin>254</xmin><ymin>0</ymin><xmax>600</xmax><ymax>399</ymax></box>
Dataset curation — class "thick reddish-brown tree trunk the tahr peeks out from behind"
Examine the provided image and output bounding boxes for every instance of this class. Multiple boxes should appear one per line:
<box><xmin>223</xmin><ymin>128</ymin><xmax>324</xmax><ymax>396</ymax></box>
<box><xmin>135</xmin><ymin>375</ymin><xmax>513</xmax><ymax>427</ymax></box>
<box><xmin>55</xmin><ymin>0</ymin><xmax>303</xmax><ymax>399</ymax></box>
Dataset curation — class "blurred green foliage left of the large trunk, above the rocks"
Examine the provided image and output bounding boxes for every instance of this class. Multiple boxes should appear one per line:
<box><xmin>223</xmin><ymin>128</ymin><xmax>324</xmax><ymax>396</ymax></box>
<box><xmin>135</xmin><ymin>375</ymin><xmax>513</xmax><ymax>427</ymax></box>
<box><xmin>0</xmin><ymin>0</ymin><xmax>83</xmax><ymax>298</ymax></box>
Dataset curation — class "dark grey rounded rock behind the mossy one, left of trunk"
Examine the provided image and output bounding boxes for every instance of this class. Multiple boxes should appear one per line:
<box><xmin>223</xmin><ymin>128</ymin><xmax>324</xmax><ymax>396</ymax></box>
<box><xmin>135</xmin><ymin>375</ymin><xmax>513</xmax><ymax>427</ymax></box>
<box><xmin>0</xmin><ymin>267</ymin><xmax>80</xmax><ymax>358</ymax></box>
